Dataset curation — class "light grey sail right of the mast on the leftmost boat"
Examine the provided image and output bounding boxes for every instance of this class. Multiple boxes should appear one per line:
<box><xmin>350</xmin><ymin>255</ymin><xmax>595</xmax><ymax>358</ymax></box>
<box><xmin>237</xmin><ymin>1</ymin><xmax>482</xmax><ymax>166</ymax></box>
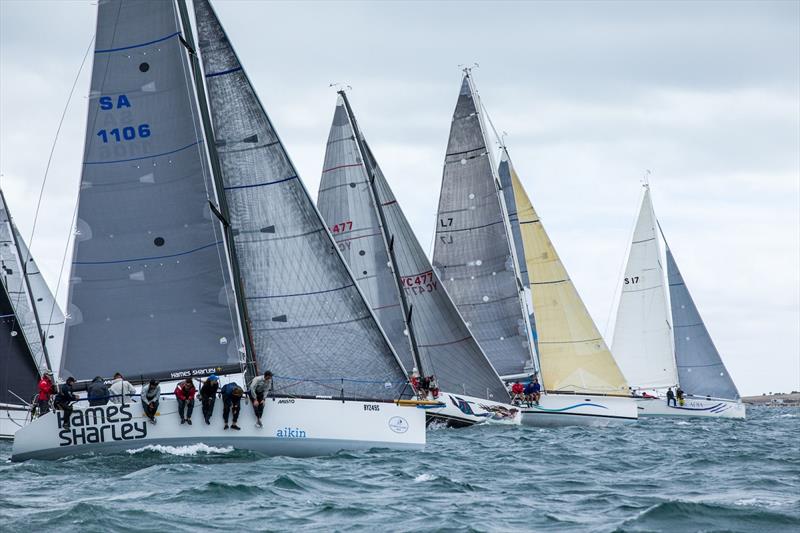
<box><xmin>13</xmin><ymin>226</ymin><xmax>65</xmax><ymax>376</ymax></box>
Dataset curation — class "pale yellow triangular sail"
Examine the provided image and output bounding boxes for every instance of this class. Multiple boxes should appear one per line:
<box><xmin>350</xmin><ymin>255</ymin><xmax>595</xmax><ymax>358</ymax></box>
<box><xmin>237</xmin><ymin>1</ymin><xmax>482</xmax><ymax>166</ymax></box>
<box><xmin>508</xmin><ymin>156</ymin><xmax>629</xmax><ymax>394</ymax></box>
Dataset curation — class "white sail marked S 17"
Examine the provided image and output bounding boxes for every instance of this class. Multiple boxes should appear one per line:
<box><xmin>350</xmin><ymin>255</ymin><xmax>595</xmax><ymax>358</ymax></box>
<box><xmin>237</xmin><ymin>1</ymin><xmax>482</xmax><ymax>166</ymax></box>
<box><xmin>611</xmin><ymin>188</ymin><xmax>678</xmax><ymax>389</ymax></box>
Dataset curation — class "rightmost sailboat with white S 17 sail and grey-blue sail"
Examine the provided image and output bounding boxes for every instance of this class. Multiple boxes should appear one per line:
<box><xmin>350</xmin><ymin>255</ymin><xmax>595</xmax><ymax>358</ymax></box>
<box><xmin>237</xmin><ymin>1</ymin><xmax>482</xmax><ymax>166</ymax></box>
<box><xmin>613</xmin><ymin>184</ymin><xmax>746</xmax><ymax>418</ymax></box>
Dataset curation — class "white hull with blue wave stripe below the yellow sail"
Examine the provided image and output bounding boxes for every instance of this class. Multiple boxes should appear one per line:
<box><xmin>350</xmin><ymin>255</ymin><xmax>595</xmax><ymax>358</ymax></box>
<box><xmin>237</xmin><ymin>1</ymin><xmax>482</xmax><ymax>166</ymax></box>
<box><xmin>522</xmin><ymin>393</ymin><xmax>638</xmax><ymax>427</ymax></box>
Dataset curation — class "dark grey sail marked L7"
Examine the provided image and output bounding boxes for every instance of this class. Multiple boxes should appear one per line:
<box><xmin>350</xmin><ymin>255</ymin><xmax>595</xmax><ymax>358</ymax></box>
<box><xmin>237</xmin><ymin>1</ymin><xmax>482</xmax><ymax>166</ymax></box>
<box><xmin>433</xmin><ymin>75</ymin><xmax>532</xmax><ymax>375</ymax></box>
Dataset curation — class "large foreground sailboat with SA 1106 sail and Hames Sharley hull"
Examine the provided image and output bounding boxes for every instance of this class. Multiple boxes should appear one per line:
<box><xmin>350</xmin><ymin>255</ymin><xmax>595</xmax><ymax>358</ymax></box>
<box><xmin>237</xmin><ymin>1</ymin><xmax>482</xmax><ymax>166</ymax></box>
<box><xmin>12</xmin><ymin>0</ymin><xmax>425</xmax><ymax>461</ymax></box>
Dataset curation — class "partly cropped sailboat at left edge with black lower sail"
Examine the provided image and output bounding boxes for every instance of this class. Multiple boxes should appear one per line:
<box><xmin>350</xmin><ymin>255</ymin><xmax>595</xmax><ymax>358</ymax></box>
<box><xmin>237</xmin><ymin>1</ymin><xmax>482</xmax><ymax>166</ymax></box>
<box><xmin>0</xmin><ymin>190</ymin><xmax>60</xmax><ymax>439</ymax></box>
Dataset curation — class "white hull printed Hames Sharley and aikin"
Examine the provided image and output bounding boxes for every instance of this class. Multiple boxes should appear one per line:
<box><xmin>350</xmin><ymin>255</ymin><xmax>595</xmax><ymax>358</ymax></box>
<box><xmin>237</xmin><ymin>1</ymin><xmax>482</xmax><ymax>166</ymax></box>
<box><xmin>11</xmin><ymin>398</ymin><xmax>425</xmax><ymax>461</ymax></box>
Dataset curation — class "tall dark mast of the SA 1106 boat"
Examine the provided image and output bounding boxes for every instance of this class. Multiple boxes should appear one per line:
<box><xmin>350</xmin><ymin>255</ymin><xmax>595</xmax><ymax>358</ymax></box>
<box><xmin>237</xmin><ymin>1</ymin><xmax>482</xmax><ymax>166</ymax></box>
<box><xmin>178</xmin><ymin>0</ymin><xmax>258</xmax><ymax>382</ymax></box>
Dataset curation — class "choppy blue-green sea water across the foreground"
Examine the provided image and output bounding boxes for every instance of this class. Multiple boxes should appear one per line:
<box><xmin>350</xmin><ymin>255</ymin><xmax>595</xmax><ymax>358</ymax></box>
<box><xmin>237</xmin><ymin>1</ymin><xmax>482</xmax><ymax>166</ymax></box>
<box><xmin>0</xmin><ymin>408</ymin><xmax>800</xmax><ymax>533</ymax></box>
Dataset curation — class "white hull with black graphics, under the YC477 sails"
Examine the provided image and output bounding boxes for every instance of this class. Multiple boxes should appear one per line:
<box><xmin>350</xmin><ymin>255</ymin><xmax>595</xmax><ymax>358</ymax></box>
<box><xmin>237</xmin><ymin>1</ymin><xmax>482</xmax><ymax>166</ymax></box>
<box><xmin>426</xmin><ymin>392</ymin><xmax>522</xmax><ymax>427</ymax></box>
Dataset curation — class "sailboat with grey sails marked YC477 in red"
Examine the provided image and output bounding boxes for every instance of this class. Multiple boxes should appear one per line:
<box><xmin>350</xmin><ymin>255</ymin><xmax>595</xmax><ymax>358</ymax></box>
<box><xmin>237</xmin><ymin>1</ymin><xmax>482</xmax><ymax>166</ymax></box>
<box><xmin>317</xmin><ymin>91</ymin><xmax>520</xmax><ymax>427</ymax></box>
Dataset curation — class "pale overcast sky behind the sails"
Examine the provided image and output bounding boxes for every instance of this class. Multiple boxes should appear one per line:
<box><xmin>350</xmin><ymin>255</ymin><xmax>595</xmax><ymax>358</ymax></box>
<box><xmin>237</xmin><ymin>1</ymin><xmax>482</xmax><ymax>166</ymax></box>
<box><xmin>0</xmin><ymin>0</ymin><xmax>800</xmax><ymax>395</ymax></box>
